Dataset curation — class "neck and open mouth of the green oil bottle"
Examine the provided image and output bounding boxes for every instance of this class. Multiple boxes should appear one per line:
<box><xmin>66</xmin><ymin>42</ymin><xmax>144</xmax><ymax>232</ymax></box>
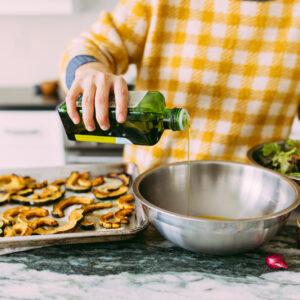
<box><xmin>163</xmin><ymin>108</ymin><xmax>190</xmax><ymax>131</ymax></box>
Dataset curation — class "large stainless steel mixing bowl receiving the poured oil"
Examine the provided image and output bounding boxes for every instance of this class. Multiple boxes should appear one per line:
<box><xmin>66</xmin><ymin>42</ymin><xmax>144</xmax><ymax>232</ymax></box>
<box><xmin>133</xmin><ymin>161</ymin><xmax>300</xmax><ymax>255</ymax></box>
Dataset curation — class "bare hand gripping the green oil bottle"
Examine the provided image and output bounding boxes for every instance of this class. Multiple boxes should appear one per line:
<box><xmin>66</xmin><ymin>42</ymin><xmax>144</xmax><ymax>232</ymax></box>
<box><xmin>66</xmin><ymin>62</ymin><xmax>128</xmax><ymax>131</ymax></box>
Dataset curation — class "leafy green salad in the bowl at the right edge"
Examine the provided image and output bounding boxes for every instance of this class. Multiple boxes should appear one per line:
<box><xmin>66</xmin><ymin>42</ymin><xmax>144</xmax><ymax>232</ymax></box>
<box><xmin>260</xmin><ymin>138</ymin><xmax>300</xmax><ymax>178</ymax></box>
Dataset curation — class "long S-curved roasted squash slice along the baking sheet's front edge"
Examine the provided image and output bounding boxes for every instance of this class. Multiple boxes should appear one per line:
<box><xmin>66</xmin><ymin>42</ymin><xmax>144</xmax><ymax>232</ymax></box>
<box><xmin>33</xmin><ymin>209</ymin><xmax>84</xmax><ymax>234</ymax></box>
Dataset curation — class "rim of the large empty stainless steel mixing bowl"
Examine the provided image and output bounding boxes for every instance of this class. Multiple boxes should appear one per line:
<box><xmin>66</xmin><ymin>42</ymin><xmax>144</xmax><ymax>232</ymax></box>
<box><xmin>133</xmin><ymin>160</ymin><xmax>300</xmax><ymax>223</ymax></box>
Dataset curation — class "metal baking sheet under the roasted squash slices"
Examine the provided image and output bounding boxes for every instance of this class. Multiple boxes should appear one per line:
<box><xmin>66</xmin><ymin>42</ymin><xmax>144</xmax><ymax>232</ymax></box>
<box><xmin>0</xmin><ymin>163</ymin><xmax>148</xmax><ymax>255</ymax></box>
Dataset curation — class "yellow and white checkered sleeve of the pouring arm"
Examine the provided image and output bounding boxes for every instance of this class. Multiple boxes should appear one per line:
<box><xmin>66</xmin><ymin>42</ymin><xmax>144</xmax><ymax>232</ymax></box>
<box><xmin>60</xmin><ymin>0</ymin><xmax>151</xmax><ymax>90</ymax></box>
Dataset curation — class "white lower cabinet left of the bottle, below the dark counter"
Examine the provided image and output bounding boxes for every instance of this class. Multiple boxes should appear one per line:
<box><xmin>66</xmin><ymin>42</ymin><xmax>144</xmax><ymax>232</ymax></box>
<box><xmin>0</xmin><ymin>111</ymin><xmax>65</xmax><ymax>169</ymax></box>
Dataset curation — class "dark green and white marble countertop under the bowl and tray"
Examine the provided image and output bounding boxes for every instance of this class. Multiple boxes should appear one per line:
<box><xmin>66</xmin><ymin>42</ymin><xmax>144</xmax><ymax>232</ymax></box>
<box><xmin>0</xmin><ymin>213</ymin><xmax>300</xmax><ymax>300</ymax></box>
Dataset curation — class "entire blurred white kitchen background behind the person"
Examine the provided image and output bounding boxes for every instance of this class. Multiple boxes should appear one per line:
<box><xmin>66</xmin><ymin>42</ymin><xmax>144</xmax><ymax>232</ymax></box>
<box><xmin>0</xmin><ymin>0</ymin><xmax>300</xmax><ymax>169</ymax></box>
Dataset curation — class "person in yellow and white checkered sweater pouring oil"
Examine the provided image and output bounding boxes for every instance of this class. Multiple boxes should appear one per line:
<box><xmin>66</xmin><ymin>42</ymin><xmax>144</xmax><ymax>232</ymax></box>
<box><xmin>61</xmin><ymin>0</ymin><xmax>300</xmax><ymax>171</ymax></box>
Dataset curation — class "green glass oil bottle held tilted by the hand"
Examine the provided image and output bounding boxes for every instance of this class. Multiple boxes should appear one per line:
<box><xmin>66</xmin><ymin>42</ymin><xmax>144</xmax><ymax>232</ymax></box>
<box><xmin>58</xmin><ymin>91</ymin><xmax>190</xmax><ymax>146</ymax></box>
